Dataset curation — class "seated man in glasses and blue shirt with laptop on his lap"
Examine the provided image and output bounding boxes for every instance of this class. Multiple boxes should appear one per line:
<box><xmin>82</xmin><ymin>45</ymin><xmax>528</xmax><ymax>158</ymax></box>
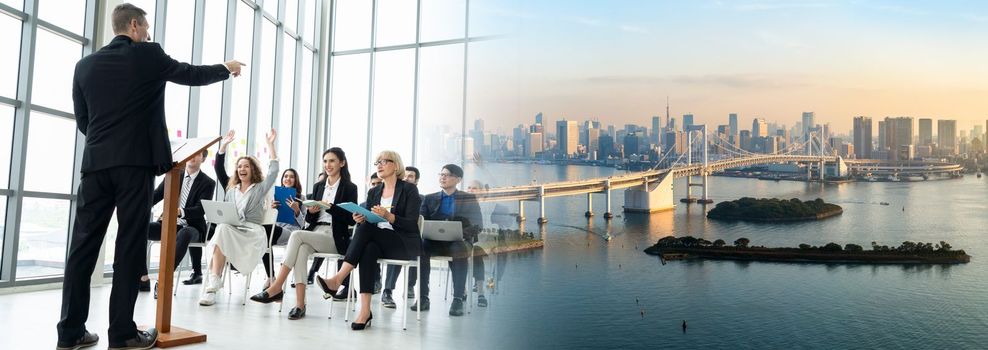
<box><xmin>410</xmin><ymin>164</ymin><xmax>487</xmax><ymax>316</ymax></box>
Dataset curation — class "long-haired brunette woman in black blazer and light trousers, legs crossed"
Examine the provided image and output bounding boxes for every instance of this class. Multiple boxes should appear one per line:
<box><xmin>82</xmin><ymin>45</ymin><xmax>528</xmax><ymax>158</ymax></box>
<box><xmin>250</xmin><ymin>147</ymin><xmax>357</xmax><ymax>320</ymax></box>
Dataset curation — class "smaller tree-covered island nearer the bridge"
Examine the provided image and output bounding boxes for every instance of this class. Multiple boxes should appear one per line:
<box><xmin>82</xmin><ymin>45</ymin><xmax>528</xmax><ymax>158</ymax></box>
<box><xmin>707</xmin><ymin>197</ymin><xmax>844</xmax><ymax>222</ymax></box>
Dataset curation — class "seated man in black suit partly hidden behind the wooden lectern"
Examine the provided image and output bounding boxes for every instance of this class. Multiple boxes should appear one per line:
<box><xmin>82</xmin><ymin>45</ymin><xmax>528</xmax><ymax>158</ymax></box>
<box><xmin>141</xmin><ymin>150</ymin><xmax>216</xmax><ymax>291</ymax></box>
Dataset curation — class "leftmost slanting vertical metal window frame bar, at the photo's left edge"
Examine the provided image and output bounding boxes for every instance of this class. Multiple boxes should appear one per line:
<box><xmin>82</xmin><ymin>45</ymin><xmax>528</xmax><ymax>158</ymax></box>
<box><xmin>0</xmin><ymin>0</ymin><xmax>38</xmax><ymax>283</ymax></box>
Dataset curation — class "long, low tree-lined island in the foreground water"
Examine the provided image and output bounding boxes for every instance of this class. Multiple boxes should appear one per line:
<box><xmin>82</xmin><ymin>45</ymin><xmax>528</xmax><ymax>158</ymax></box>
<box><xmin>645</xmin><ymin>236</ymin><xmax>971</xmax><ymax>264</ymax></box>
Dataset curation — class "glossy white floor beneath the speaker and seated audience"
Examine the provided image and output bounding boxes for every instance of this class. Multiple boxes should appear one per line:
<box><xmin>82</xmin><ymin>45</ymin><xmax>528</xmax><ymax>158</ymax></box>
<box><xmin>0</xmin><ymin>269</ymin><xmax>494</xmax><ymax>350</ymax></box>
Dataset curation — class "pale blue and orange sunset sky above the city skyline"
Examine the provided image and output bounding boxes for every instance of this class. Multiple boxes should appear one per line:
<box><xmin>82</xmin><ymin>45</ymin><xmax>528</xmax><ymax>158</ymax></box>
<box><xmin>468</xmin><ymin>0</ymin><xmax>988</xmax><ymax>134</ymax></box>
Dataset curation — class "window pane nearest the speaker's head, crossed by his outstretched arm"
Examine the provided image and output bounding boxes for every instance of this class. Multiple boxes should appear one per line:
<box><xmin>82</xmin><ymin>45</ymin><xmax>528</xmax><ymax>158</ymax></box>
<box><xmin>164</xmin><ymin>1</ymin><xmax>195</xmax><ymax>140</ymax></box>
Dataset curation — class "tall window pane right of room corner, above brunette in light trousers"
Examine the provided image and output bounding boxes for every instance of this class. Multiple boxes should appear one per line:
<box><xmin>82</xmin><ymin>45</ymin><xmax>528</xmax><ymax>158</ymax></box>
<box><xmin>328</xmin><ymin>54</ymin><xmax>370</xmax><ymax>193</ymax></box>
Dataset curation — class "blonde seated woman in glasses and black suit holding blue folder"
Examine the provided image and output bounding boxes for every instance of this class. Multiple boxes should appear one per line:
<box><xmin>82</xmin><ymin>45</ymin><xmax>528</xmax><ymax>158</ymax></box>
<box><xmin>316</xmin><ymin>151</ymin><xmax>422</xmax><ymax>330</ymax></box>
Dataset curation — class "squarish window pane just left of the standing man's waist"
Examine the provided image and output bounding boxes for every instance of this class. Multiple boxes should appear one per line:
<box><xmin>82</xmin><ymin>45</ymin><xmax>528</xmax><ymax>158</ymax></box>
<box><xmin>24</xmin><ymin>111</ymin><xmax>77</xmax><ymax>193</ymax></box>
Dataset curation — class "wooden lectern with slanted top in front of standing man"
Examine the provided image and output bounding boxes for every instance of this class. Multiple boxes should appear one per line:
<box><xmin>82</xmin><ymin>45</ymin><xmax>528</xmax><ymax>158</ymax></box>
<box><xmin>149</xmin><ymin>137</ymin><xmax>220</xmax><ymax>348</ymax></box>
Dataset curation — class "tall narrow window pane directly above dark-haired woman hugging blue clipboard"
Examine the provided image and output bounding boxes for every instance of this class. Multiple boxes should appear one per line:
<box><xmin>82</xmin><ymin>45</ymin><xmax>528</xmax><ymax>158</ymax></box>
<box><xmin>278</xmin><ymin>34</ymin><xmax>303</xmax><ymax>171</ymax></box>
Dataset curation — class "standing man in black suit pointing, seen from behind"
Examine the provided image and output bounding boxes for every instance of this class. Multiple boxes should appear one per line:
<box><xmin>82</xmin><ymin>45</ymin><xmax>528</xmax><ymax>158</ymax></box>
<box><xmin>57</xmin><ymin>4</ymin><xmax>243</xmax><ymax>349</ymax></box>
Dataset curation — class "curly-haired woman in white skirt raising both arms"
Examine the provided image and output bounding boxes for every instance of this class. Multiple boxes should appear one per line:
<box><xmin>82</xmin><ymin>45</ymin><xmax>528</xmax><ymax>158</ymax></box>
<box><xmin>199</xmin><ymin>129</ymin><xmax>278</xmax><ymax>306</ymax></box>
